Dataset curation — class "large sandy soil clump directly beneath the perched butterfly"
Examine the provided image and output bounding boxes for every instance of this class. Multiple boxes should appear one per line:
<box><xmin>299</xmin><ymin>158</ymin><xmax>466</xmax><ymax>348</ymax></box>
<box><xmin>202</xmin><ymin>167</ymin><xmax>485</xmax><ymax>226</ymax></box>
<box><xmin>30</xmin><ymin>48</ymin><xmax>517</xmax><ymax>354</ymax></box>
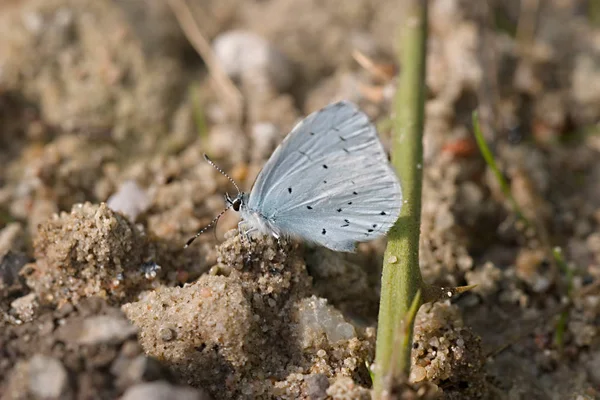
<box><xmin>123</xmin><ymin>235</ymin><xmax>373</xmax><ymax>398</ymax></box>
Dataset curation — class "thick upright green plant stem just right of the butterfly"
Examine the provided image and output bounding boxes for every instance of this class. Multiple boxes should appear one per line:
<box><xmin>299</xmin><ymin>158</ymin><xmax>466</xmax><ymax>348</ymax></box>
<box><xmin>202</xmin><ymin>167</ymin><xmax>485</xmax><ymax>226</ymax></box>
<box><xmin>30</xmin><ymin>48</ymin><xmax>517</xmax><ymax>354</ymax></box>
<box><xmin>374</xmin><ymin>0</ymin><xmax>427</xmax><ymax>399</ymax></box>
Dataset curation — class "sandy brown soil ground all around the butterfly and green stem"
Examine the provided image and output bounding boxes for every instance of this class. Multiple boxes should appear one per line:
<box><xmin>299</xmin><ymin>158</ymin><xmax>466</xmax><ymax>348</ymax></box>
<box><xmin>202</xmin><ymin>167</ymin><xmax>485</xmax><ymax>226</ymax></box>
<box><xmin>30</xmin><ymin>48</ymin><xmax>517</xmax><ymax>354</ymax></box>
<box><xmin>0</xmin><ymin>0</ymin><xmax>600</xmax><ymax>400</ymax></box>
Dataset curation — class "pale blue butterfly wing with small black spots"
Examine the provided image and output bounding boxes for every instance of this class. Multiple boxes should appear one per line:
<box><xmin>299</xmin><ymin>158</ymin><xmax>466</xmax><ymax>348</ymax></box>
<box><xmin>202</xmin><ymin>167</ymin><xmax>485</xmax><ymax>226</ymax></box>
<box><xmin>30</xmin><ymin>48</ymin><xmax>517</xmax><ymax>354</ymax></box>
<box><xmin>248</xmin><ymin>101</ymin><xmax>402</xmax><ymax>251</ymax></box>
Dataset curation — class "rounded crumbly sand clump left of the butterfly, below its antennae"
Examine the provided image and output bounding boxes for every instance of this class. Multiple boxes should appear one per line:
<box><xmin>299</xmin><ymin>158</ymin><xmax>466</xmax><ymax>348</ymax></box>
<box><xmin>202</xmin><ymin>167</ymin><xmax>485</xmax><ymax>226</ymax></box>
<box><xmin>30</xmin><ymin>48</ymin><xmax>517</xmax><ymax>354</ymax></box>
<box><xmin>23</xmin><ymin>203</ymin><xmax>151</xmax><ymax>304</ymax></box>
